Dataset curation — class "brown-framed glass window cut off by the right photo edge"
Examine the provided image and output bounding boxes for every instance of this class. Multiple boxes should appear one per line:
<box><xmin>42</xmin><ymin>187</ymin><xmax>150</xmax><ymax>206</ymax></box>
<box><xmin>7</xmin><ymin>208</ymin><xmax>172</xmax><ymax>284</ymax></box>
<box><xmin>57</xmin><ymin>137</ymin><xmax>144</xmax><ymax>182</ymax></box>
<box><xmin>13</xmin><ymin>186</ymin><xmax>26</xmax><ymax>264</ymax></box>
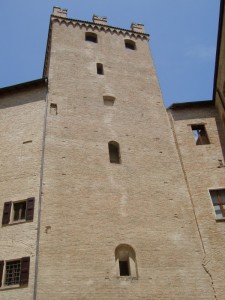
<box><xmin>209</xmin><ymin>189</ymin><xmax>225</xmax><ymax>219</ymax></box>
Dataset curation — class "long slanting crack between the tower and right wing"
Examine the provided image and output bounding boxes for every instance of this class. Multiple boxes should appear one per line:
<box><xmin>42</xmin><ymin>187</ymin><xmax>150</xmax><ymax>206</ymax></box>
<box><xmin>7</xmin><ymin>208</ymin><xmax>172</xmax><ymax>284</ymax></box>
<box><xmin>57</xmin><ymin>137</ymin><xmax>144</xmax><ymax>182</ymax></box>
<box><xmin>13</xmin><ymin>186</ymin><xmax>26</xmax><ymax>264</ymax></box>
<box><xmin>167</xmin><ymin>110</ymin><xmax>217</xmax><ymax>299</ymax></box>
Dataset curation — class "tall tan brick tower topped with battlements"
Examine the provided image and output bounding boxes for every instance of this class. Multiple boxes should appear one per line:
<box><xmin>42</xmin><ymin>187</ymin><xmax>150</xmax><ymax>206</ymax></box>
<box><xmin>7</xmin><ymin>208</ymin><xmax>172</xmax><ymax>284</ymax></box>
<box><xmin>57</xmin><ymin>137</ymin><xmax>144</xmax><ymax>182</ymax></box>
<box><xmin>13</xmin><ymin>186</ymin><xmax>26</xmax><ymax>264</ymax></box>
<box><xmin>33</xmin><ymin>8</ymin><xmax>212</xmax><ymax>300</ymax></box>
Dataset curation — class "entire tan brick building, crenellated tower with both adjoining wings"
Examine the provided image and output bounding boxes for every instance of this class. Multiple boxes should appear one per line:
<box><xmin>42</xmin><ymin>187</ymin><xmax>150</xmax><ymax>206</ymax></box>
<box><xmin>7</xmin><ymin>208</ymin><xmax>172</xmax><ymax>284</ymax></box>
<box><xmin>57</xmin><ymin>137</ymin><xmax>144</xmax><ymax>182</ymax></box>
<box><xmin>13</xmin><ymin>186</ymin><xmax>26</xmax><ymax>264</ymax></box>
<box><xmin>0</xmin><ymin>7</ymin><xmax>225</xmax><ymax>300</ymax></box>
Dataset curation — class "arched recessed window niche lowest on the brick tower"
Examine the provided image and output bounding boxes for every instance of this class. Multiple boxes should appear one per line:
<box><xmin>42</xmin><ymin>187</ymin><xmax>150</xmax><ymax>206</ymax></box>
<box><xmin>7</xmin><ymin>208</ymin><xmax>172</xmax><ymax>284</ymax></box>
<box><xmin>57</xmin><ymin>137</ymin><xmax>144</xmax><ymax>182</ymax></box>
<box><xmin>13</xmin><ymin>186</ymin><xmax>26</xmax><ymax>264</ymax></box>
<box><xmin>115</xmin><ymin>244</ymin><xmax>137</xmax><ymax>277</ymax></box>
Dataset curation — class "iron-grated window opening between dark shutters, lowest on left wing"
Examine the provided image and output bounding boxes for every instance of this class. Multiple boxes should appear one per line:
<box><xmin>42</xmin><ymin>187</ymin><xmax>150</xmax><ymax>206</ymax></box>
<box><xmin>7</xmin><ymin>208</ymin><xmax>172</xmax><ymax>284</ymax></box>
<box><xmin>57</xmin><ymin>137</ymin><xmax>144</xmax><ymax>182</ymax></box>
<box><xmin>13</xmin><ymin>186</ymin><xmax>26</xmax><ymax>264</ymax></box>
<box><xmin>5</xmin><ymin>260</ymin><xmax>21</xmax><ymax>286</ymax></box>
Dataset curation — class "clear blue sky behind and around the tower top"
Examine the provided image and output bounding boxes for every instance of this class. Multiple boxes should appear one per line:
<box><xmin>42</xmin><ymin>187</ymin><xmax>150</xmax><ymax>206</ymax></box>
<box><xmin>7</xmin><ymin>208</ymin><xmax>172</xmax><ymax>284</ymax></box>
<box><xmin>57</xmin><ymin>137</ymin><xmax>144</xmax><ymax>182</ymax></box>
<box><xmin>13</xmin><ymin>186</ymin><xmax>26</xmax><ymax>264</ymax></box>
<box><xmin>0</xmin><ymin>0</ymin><xmax>220</xmax><ymax>106</ymax></box>
